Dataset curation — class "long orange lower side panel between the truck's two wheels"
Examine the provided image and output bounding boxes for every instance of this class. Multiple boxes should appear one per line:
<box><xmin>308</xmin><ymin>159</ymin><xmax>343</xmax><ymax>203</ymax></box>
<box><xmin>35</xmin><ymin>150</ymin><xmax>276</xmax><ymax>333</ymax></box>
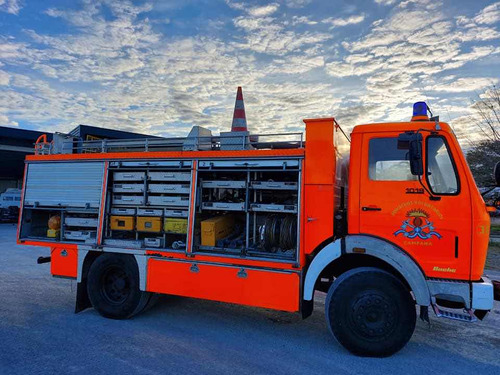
<box><xmin>147</xmin><ymin>259</ymin><xmax>300</xmax><ymax>312</ymax></box>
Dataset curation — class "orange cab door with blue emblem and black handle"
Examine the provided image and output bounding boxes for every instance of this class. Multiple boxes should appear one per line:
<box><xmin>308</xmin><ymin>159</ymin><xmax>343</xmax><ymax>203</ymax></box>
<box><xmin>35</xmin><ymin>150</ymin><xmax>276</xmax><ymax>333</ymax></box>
<box><xmin>359</xmin><ymin>132</ymin><xmax>471</xmax><ymax>280</ymax></box>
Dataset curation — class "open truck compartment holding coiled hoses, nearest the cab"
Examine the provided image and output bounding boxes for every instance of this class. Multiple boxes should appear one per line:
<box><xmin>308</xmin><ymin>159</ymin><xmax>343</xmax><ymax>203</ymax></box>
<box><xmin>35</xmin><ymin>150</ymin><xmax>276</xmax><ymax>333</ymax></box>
<box><xmin>193</xmin><ymin>160</ymin><xmax>301</xmax><ymax>262</ymax></box>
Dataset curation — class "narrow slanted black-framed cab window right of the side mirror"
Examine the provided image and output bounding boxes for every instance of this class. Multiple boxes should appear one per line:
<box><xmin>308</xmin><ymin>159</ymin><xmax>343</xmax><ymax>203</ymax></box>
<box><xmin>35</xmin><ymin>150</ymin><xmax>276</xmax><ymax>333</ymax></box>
<box><xmin>426</xmin><ymin>136</ymin><xmax>459</xmax><ymax>195</ymax></box>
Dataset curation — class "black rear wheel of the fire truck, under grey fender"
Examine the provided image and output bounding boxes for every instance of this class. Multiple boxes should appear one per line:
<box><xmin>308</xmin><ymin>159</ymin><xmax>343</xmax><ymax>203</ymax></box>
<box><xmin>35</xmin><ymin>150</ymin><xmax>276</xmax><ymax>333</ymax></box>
<box><xmin>87</xmin><ymin>253</ymin><xmax>151</xmax><ymax>319</ymax></box>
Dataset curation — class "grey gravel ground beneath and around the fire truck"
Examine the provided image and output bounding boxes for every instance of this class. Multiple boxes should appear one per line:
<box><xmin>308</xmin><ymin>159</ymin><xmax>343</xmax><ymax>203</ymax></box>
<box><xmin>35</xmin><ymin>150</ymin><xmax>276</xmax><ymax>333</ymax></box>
<box><xmin>0</xmin><ymin>224</ymin><xmax>500</xmax><ymax>375</ymax></box>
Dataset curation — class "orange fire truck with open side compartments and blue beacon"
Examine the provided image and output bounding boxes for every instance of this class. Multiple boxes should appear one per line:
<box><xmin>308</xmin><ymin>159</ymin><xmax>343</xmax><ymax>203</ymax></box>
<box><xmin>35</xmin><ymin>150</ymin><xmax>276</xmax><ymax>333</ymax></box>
<box><xmin>18</xmin><ymin>102</ymin><xmax>493</xmax><ymax>356</ymax></box>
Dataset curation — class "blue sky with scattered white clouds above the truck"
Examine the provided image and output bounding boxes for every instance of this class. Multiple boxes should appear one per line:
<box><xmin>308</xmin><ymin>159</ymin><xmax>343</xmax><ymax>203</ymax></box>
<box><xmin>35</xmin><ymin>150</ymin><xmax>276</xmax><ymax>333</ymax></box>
<box><xmin>0</xmin><ymin>0</ymin><xmax>500</xmax><ymax>144</ymax></box>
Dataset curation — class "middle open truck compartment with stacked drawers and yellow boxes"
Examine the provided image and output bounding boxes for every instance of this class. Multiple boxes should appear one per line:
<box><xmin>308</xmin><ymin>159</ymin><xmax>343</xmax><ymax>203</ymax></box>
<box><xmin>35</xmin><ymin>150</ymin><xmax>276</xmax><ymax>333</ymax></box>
<box><xmin>104</xmin><ymin>160</ymin><xmax>192</xmax><ymax>251</ymax></box>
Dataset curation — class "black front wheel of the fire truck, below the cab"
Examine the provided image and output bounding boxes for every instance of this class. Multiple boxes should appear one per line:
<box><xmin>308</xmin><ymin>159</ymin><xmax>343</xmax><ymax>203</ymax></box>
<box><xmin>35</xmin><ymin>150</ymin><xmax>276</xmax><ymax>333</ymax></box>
<box><xmin>325</xmin><ymin>267</ymin><xmax>417</xmax><ymax>357</ymax></box>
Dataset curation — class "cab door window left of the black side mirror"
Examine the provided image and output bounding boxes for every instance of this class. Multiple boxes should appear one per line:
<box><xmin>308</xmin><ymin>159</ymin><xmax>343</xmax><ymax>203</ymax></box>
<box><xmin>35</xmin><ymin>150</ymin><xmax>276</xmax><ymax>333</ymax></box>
<box><xmin>368</xmin><ymin>137</ymin><xmax>417</xmax><ymax>181</ymax></box>
